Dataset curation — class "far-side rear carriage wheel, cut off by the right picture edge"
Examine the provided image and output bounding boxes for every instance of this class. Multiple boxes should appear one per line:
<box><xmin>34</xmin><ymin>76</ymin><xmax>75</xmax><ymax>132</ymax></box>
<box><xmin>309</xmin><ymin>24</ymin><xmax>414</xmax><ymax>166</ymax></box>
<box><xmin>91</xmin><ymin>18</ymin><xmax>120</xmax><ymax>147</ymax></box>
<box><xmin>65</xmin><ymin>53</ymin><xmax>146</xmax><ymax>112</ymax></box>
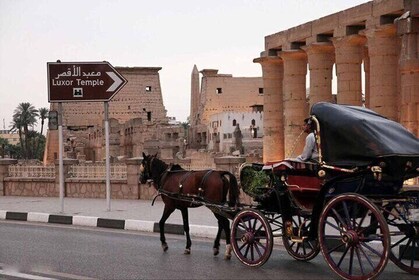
<box><xmin>382</xmin><ymin>191</ymin><xmax>419</xmax><ymax>275</ymax></box>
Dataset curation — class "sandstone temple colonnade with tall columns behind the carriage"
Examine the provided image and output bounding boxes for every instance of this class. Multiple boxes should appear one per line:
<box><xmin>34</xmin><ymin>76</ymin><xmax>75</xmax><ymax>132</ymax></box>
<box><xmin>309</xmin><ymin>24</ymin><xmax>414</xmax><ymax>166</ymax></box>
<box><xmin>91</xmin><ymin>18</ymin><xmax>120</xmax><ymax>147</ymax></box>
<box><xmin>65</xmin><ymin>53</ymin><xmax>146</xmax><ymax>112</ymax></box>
<box><xmin>254</xmin><ymin>0</ymin><xmax>419</xmax><ymax>162</ymax></box>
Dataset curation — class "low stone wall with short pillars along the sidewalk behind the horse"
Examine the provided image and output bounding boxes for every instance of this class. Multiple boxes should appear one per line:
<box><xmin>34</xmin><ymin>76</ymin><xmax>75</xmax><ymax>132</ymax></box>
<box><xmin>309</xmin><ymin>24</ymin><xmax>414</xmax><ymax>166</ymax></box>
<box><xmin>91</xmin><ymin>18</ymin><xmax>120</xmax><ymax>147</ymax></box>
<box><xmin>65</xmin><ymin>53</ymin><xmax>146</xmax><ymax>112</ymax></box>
<box><xmin>0</xmin><ymin>157</ymin><xmax>249</xmax><ymax>200</ymax></box>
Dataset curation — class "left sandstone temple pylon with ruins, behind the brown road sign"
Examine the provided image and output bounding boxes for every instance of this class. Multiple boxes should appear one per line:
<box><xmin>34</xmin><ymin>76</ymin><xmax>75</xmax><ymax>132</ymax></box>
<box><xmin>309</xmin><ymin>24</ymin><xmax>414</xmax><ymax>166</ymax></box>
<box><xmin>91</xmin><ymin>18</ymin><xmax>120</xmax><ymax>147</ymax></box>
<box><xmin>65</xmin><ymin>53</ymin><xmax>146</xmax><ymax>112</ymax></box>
<box><xmin>44</xmin><ymin>67</ymin><xmax>184</xmax><ymax>163</ymax></box>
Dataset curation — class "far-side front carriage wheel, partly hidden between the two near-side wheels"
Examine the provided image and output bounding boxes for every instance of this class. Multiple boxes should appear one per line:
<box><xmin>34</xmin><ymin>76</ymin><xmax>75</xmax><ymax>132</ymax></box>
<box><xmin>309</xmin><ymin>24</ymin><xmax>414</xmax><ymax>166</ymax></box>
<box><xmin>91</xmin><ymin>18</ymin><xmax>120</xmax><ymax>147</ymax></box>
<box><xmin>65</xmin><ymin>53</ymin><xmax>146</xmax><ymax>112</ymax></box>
<box><xmin>282</xmin><ymin>215</ymin><xmax>320</xmax><ymax>261</ymax></box>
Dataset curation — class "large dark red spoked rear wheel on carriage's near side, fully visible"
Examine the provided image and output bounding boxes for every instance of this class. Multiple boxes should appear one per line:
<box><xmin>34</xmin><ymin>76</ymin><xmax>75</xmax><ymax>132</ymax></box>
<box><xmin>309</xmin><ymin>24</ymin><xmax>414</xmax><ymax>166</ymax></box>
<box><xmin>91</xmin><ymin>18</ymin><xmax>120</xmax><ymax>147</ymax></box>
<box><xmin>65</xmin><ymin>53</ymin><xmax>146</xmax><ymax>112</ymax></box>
<box><xmin>318</xmin><ymin>194</ymin><xmax>390</xmax><ymax>279</ymax></box>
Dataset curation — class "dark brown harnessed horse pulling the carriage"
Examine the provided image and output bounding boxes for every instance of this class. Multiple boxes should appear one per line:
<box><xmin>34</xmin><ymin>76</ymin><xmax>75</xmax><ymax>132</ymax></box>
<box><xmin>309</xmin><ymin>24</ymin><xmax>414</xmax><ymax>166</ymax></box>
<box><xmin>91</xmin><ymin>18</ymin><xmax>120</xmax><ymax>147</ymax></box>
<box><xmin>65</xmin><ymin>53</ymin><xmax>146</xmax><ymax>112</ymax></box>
<box><xmin>140</xmin><ymin>153</ymin><xmax>240</xmax><ymax>260</ymax></box>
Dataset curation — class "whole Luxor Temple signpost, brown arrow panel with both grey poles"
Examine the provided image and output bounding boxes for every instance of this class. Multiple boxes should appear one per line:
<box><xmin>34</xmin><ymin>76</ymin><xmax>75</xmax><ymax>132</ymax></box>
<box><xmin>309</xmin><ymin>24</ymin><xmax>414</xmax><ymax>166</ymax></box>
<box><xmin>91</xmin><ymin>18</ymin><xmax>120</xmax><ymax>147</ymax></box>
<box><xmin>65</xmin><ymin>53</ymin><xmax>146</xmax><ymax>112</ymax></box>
<box><xmin>47</xmin><ymin>61</ymin><xmax>127</xmax><ymax>212</ymax></box>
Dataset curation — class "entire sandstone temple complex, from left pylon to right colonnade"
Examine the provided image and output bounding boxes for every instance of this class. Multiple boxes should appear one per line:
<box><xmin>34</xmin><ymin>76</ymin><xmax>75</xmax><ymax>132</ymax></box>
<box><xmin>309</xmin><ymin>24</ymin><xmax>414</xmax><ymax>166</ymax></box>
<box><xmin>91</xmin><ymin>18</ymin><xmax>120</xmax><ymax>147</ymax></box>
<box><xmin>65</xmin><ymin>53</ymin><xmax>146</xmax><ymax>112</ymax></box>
<box><xmin>44</xmin><ymin>0</ymin><xmax>419</xmax><ymax>163</ymax></box>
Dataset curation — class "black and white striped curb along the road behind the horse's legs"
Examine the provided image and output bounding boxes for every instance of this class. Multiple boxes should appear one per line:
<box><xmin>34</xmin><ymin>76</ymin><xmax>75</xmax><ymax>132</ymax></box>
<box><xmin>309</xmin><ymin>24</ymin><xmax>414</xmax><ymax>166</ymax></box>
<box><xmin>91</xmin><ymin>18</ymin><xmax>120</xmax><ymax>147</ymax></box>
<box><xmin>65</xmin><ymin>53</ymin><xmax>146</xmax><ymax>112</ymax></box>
<box><xmin>0</xmin><ymin>210</ymin><xmax>217</xmax><ymax>238</ymax></box>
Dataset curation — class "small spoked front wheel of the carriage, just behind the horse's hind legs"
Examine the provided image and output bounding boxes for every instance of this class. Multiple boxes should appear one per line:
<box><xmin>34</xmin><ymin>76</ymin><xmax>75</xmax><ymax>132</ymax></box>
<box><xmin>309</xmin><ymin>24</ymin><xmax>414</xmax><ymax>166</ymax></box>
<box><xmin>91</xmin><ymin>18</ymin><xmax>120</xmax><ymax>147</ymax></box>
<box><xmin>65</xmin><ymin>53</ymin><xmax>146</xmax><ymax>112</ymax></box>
<box><xmin>231</xmin><ymin>209</ymin><xmax>273</xmax><ymax>267</ymax></box>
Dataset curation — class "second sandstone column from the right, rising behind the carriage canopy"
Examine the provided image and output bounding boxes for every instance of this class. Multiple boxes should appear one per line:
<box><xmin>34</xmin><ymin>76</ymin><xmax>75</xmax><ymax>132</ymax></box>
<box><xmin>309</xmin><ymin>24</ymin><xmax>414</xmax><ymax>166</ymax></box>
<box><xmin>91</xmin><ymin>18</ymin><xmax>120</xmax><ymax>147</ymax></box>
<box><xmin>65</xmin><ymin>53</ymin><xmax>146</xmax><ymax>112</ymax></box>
<box><xmin>364</xmin><ymin>25</ymin><xmax>399</xmax><ymax>121</ymax></box>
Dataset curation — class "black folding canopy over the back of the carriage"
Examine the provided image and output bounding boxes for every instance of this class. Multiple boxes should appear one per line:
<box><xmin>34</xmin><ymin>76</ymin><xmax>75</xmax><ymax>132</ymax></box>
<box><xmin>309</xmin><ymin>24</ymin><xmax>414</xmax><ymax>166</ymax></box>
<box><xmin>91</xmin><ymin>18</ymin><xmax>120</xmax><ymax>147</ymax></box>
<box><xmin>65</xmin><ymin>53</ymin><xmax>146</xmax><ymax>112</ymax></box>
<box><xmin>310</xmin><ymin>102</ymin><xmax>419</xmax><ymax>168</ymax></box>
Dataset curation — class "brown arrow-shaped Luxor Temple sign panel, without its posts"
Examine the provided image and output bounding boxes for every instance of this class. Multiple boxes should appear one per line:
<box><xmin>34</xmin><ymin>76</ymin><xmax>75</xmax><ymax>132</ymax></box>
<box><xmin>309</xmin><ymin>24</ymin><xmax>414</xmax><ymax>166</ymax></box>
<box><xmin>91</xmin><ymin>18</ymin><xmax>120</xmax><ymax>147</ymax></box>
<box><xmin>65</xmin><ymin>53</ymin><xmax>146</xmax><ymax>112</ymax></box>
<box><xmin>47</xmin><ymin>61</ymin><xmax>127</xmax><ymax>102</ymax></box>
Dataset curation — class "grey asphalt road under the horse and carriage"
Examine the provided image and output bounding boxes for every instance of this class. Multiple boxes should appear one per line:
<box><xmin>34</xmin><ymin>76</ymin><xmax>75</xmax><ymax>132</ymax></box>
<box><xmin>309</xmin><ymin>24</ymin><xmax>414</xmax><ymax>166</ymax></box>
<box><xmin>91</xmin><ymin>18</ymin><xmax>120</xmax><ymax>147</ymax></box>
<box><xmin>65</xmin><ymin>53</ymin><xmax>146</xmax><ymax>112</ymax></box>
<box><xmin>0</xmin><ymin>221</ymin><xmax>417</xmax><ymax>280</ymax></box>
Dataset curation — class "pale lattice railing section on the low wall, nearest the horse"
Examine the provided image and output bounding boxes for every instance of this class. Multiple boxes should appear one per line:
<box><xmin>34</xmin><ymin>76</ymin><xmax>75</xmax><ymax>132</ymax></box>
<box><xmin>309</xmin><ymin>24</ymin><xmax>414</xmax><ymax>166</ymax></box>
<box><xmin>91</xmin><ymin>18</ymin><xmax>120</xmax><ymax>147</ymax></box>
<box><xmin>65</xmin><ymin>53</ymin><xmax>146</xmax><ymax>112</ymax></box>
<box><xmin>68</xmin><ymin>163</ymin><xmax>127</xmax><ymax>179</ymax></box>
